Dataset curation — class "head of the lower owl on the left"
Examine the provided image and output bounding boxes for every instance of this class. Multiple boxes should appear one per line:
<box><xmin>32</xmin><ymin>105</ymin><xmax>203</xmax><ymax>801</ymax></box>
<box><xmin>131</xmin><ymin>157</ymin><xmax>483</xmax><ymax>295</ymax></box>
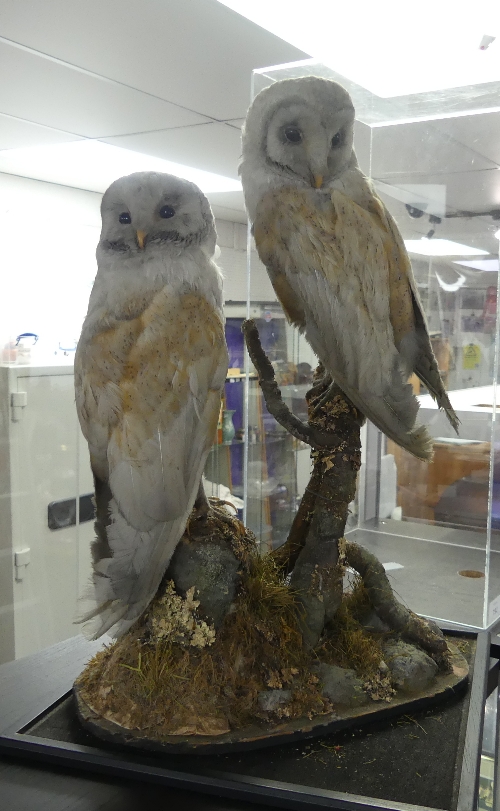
<box><xmin>98</xmin><ymin>172</ymin><xmax>216</xmax><ymax>256</ymax></box>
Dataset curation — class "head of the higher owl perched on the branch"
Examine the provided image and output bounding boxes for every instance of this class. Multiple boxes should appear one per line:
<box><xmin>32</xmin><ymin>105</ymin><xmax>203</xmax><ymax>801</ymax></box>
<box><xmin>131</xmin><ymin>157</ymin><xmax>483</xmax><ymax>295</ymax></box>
<box><xmin>240</xmin><ymin>76</ymin><xmax>356</xmax><ymax>213</ymax></box>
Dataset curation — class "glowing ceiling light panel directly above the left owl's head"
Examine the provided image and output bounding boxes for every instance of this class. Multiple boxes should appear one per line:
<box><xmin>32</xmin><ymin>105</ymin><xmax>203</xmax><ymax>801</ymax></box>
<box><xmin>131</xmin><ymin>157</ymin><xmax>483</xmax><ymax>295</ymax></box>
<box><xmin>0</xmin><ymin>140</ymin><xmax>241</xmax><ymax>194</ymax></box>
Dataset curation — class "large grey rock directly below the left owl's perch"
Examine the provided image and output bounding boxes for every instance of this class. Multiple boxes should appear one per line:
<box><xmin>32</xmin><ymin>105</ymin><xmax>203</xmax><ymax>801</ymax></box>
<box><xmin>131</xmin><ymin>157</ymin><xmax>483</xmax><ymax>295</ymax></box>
<box><xmin>167</xmin><ymin>538</ymin><xmax>241</xmax><ymax>628</ymax></box>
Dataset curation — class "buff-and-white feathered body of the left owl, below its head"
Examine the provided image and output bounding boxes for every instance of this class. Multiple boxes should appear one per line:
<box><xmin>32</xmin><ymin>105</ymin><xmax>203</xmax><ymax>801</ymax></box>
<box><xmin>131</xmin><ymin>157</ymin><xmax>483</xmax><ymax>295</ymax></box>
<box><xmin>75</xmin><ymin>289</ymin><xmax>227</xmax><ymax>637</ymax></box>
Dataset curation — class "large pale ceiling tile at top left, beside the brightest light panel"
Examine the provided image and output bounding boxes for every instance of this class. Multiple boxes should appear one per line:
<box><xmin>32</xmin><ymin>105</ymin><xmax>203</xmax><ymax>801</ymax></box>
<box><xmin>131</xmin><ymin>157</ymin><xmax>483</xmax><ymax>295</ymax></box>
<box><xmin>0</xmin><ymin>0</ymin><xmax>308</xmax><ymax>120</ymax></box>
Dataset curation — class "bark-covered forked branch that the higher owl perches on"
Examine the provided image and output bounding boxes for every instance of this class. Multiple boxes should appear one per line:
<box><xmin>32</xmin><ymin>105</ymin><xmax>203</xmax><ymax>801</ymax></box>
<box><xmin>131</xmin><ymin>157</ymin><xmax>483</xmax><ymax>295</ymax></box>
<box><xmin>242</xmin><ymin>321</ymin><xmax>447</xmax><ymax>656</ymax></box>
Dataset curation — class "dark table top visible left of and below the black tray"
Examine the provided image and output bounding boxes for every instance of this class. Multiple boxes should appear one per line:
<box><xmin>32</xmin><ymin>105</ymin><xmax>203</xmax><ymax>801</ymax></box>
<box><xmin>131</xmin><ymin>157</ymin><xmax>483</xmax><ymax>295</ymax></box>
<box><xmin>0</xmin><ymin>638</ymin><xmax>270</xmax><ymax>811</ymax></box>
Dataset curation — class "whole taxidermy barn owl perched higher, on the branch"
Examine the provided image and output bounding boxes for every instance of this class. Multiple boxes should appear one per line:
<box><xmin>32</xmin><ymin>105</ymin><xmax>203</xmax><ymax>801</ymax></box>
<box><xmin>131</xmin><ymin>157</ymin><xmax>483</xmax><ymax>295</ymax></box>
<box><xmin>240</xmin><ymin>76</ymin><xmax>458</xmax><ymax>459</ymax></box>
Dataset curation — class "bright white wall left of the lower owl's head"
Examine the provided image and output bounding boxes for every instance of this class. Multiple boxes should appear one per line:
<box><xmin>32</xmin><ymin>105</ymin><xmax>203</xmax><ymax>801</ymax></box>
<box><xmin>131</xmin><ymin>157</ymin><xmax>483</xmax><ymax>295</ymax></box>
<box><xmin>0</xmin><ymin>174</ymin><xmax>101</xmax><ymax>358</ymax></box>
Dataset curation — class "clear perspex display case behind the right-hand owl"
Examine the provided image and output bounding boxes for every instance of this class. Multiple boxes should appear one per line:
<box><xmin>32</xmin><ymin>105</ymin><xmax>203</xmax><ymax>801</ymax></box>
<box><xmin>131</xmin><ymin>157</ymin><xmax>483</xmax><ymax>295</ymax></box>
<box><xmin>248</xmin><ymin>60</ymin><xmax>500</xmax><ymax>627</ymax></box>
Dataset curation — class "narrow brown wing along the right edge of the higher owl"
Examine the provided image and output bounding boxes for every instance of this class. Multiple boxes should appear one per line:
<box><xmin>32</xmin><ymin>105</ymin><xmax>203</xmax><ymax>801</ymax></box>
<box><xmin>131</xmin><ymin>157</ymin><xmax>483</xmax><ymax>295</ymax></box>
<box><xmin>374</xmin><ymin>195</ymin><xmax>460</xmax><ymax>433</ymax></box>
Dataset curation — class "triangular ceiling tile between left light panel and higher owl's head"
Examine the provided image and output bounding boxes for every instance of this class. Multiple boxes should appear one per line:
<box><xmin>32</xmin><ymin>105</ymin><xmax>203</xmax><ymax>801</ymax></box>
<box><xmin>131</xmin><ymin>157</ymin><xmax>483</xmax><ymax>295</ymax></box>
<box><xmin>101</xmin><ymin>124</ymin><xmax>241</xmax><ymax>178</ymax></box>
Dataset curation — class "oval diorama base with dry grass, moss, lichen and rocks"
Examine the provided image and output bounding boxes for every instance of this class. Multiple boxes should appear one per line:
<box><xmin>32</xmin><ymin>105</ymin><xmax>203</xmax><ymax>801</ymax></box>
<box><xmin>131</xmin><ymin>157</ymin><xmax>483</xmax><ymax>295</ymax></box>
<box><xmin>74</xmin><ymin>502</ymin><xmax>469</xmax><ymax>754</ymax></box>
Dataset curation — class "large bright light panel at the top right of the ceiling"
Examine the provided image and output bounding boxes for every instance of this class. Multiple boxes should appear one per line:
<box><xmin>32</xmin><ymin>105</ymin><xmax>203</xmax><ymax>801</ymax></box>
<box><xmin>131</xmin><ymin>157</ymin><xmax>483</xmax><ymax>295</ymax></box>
<box><xmin>220</xmin><ymin>0</ymin><xmax>500</xmax><ymax>97</ymax></box>
